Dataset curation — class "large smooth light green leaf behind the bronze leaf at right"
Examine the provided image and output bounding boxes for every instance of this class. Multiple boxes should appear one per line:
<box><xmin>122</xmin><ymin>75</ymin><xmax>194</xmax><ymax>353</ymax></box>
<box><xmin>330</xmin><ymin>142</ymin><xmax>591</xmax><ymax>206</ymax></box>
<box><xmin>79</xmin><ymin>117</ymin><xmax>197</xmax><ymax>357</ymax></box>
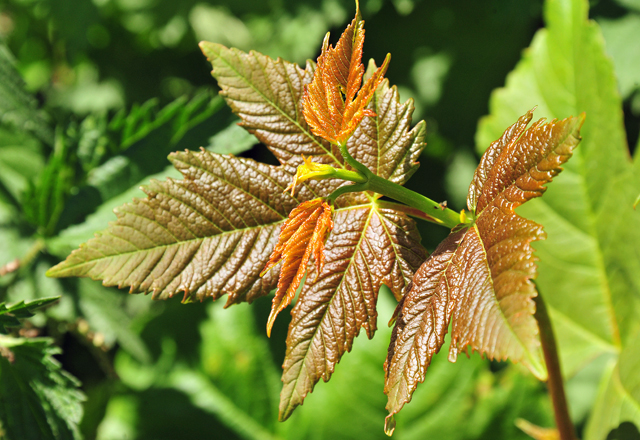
<box><xmin>476</xmin><ymin>0</ymin><xmax>640</xmax><ymax>434</ymax></box>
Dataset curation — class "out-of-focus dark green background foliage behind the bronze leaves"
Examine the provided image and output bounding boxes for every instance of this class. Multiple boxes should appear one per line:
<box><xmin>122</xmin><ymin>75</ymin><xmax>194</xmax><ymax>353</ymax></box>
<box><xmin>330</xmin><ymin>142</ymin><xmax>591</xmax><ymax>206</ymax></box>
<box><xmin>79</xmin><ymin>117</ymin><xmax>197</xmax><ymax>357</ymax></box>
<box><xmin>0</xmin><ymin>0</ymin><xmax>640</xmax><ymax>439</ymax></box>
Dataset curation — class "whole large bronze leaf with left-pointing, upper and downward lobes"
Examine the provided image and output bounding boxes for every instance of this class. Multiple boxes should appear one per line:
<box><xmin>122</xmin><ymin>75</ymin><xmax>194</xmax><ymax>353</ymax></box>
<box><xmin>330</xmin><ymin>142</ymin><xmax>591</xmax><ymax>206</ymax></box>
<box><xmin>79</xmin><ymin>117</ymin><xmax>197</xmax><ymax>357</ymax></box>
<box><xmin>48</xmin><ymin>4</ymin><xmax>427</xmax><ymax>420</ymax></box>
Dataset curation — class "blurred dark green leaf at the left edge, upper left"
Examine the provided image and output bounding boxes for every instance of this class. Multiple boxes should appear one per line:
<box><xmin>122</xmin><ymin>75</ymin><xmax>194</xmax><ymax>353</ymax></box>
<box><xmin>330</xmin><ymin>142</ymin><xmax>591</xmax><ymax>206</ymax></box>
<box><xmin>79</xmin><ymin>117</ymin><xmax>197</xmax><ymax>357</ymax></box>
<box><xmin>0</xmin><ymin>43</ymin><xmax>53</xmax><ymax>145</ymax></box>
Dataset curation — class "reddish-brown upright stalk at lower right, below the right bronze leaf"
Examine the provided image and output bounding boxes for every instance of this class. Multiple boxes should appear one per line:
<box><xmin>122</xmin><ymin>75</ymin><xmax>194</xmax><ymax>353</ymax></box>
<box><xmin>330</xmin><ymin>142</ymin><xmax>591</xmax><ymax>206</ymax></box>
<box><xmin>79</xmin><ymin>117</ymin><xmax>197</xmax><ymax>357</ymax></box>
<box><xmin>535</xmin><ymin>294</ymin><xmax>577</xmax><ymax>440</ymax></box>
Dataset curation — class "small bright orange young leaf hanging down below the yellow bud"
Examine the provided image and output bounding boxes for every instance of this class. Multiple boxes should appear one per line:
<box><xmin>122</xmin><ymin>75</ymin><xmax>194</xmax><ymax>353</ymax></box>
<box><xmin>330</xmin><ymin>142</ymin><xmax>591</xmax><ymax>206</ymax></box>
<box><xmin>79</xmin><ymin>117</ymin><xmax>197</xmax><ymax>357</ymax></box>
<box><xmin>261</xmin><ymin>199</ymin><xmax>333</xmax><ymax>336</ymax></box>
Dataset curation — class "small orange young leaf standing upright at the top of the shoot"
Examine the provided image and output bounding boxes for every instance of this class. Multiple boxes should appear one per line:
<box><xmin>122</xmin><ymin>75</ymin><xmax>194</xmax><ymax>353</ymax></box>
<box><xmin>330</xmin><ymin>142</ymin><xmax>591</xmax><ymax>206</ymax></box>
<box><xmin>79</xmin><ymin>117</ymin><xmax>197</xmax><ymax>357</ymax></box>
<box><xmin>303</xmin><ymin>5</ymin><xmax>390</xmax><ymax>144</ymax></box>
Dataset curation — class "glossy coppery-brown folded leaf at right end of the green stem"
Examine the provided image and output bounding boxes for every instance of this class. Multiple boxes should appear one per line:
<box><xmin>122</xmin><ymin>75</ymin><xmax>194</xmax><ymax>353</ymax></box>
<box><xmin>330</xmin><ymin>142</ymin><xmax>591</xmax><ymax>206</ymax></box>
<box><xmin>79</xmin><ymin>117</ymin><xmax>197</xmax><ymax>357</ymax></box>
<box><xmin>385</xmin><ymin>110</ymin><xmax>584</xmax><ymax>431</ymax></box>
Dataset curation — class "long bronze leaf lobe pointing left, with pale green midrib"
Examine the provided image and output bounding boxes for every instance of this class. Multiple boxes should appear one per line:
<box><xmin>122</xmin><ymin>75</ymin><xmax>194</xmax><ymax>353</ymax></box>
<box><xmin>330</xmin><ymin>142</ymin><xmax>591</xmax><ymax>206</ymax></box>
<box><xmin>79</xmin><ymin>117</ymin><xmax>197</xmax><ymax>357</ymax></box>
<box><xmin>48</xmin><ymin>151</ymin><xmax>335</xmax><ymax>304</ymax></box>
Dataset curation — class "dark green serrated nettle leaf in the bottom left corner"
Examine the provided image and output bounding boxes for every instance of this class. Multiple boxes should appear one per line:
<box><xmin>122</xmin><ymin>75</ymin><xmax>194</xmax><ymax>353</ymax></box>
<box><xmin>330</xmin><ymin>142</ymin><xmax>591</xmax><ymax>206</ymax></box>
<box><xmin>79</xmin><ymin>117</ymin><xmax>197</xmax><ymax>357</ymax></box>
<box><xmin>0</xmin><ymin>336</ymin><xmax>84</xmax><ymax>440</ymax></box>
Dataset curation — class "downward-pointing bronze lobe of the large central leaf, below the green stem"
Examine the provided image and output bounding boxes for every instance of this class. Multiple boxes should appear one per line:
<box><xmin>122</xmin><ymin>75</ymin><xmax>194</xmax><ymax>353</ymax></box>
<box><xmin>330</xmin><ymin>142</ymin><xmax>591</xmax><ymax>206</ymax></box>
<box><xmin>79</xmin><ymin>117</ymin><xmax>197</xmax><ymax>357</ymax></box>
<box><xmin>280</xmin><ymin>203</ymin><xmax>426</xmax><ymax>420</ymax></box>
